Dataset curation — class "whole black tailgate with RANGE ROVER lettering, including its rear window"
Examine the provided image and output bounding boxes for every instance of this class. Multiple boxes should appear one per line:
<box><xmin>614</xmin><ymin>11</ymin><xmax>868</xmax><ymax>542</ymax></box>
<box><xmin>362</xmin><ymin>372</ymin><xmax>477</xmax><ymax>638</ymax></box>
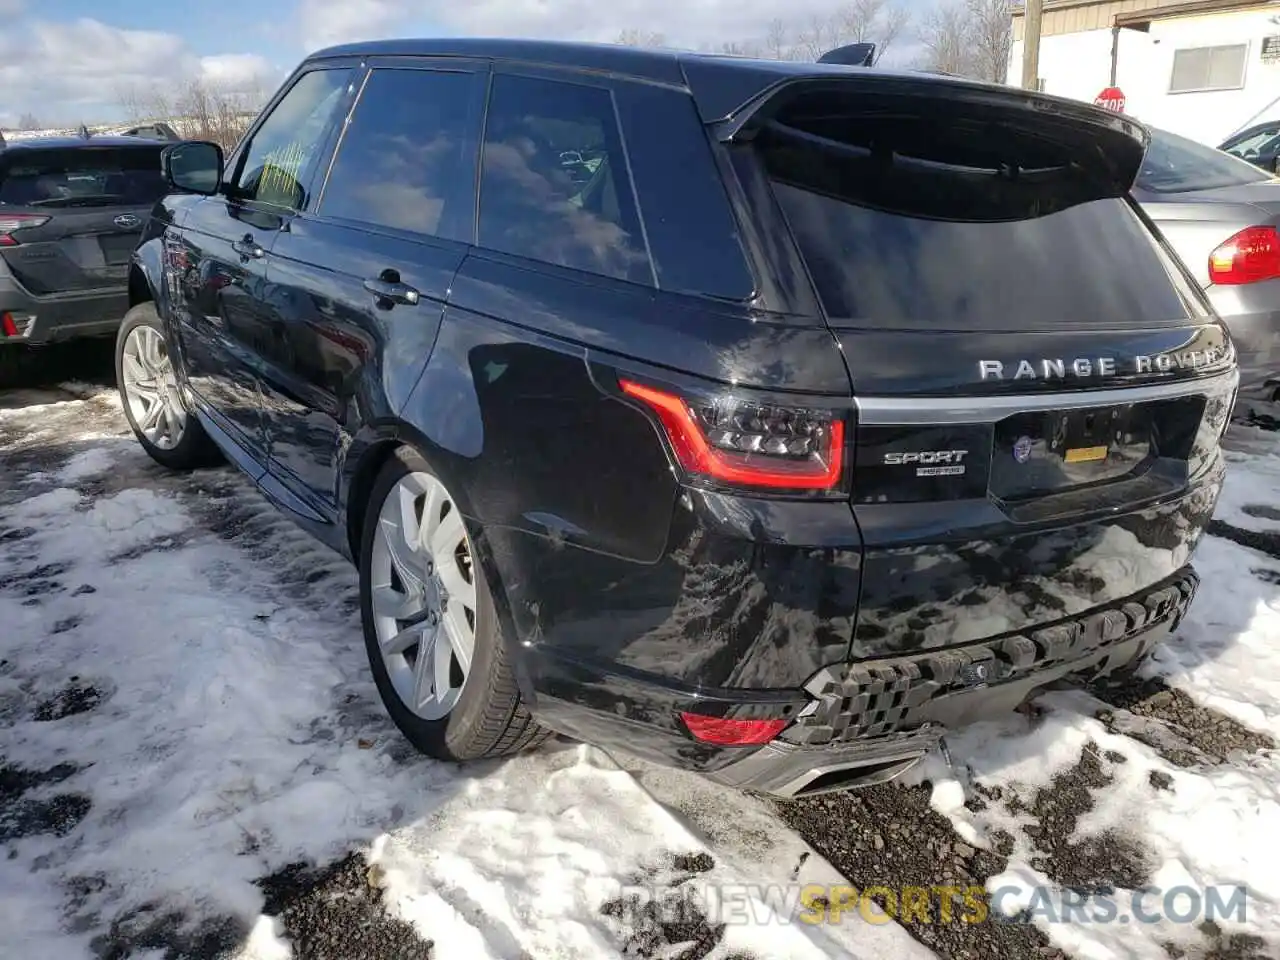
<box><xmin>750</xmin><ymin>81</ymin><xmax>1235</xmax><ymax>659</ymax></box>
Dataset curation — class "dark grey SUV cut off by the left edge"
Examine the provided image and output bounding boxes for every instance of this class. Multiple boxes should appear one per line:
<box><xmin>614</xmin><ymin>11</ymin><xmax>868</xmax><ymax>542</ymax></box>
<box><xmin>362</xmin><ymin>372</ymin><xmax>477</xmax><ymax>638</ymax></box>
<box><xmin>0</xmin><ymin>134</ymin><xmax>170</xmax><ymax>370</ymax></box>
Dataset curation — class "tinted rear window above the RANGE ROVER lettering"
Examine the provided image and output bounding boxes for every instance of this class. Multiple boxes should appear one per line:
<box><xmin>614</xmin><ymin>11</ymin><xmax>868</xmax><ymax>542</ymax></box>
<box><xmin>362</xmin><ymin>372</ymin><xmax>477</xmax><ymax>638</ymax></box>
<box><xmin>759</xmin><ymin>116</ymin><xmax>1192</xmax><ymax>330</ymax></box>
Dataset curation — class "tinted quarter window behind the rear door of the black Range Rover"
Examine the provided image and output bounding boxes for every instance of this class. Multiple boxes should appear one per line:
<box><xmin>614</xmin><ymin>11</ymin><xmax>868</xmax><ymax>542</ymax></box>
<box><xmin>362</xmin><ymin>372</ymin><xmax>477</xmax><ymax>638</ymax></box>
<box><xmin>479</xmin><ymin>74</ymin><xmax>653</xmax><ymax>285</ymax></box>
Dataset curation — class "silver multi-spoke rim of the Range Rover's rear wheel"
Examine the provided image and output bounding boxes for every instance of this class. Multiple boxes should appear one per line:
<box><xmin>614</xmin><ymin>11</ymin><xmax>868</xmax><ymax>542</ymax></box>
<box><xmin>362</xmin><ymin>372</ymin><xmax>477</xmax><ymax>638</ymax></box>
<box><xmin>369</xmin><ymin>474</ymin><xmax>476</xmax><ymax>721</ymax></box>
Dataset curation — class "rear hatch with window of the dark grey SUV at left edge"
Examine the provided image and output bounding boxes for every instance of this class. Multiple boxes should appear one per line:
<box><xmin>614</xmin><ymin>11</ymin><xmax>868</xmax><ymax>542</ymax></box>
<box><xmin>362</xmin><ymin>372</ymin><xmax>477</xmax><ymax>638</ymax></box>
<box><xmin>0</xmin><ymin>143</ymin><xmax>168</xmax><ymax>294</ymax></box>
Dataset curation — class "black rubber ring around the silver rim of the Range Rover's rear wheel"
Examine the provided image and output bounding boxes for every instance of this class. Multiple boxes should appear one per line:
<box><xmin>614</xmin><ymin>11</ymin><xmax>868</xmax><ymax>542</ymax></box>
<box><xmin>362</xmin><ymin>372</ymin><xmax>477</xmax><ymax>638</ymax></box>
<box><xmin>360</xmin><ymin>448</ymin><xmax>503</xmax><ymax>760</ymax></box>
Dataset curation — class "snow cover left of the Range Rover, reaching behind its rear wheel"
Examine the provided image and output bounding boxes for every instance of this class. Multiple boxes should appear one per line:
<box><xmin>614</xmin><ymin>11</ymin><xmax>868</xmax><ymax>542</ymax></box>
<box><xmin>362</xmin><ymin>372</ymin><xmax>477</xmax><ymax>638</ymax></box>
<box><xmin>0</xmin><ymin>392</ymin><xmax>931</xmax><ymax>960</ymax></box>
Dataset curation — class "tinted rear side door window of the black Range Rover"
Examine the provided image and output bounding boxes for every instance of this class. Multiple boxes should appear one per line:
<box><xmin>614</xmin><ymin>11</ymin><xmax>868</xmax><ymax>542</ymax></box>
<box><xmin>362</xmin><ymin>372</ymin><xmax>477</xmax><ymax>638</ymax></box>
<box><xmin>319</xmin><ymin>69</ymin><xmax>479</xmax><ymax>243</ymax></box>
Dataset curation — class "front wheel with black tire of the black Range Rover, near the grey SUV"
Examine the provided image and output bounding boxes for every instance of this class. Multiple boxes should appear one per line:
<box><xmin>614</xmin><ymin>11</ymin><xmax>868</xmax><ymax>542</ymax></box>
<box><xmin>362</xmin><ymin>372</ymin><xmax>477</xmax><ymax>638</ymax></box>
<box><xmin>115</xmin><ymin>302</ymin><xmax>223</xmax><ymax>470</ymax></box>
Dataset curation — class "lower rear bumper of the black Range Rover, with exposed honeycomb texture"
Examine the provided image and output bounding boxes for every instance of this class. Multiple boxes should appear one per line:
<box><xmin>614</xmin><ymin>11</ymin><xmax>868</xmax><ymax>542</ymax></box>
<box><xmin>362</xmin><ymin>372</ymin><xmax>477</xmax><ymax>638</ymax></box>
<box><xmin>526</xmin><ymin>566</ymin><xmax>1199</xmax><ymax>799</ymax></box>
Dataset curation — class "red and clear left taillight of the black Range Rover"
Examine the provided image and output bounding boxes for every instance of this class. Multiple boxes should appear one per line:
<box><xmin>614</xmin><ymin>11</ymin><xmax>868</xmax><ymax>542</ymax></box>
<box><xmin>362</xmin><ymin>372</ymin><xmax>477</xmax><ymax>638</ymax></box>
<box><xmin>620</xmin><ymin>380</ymin><xmax>845</xmax><ymax>490</ymax></box>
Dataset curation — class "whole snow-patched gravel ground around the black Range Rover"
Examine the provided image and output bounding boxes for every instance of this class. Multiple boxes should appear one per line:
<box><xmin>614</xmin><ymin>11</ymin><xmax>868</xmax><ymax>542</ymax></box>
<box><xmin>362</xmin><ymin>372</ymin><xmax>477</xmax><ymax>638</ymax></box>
<box><xmin>0</xmin><ymin>355</ymin><xmax>1280</xmax><ymax>960</ymax></box>
